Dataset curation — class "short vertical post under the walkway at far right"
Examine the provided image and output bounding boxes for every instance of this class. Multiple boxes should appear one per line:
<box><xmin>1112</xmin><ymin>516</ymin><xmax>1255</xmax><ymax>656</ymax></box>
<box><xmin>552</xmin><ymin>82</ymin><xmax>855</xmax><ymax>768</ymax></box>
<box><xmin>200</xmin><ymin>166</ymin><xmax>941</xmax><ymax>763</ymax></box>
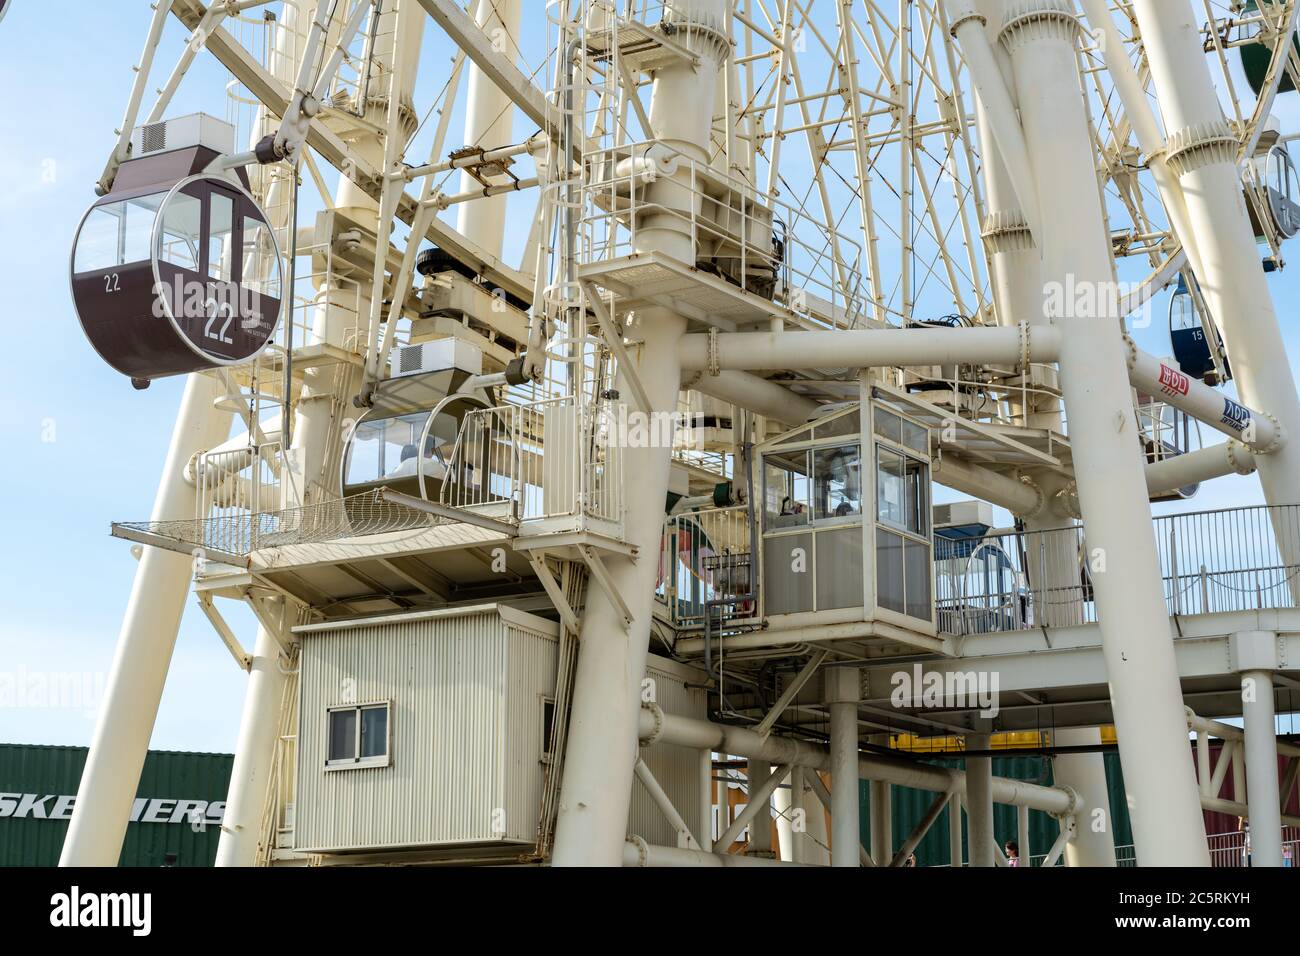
<box><xmin>1234</xmin><ymin>670</ymin><xmax>1282</xmax><ymax>866</ymax></box>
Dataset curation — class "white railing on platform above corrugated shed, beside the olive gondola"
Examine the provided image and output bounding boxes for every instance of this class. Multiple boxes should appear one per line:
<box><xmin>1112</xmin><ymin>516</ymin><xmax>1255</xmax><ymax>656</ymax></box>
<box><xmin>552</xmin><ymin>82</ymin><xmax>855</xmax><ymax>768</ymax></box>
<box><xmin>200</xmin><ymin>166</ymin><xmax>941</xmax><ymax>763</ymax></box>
<box><xmin>441</xmin><ymin>397</ymin><xmax>624</xmax><ymax>524</ymax></box>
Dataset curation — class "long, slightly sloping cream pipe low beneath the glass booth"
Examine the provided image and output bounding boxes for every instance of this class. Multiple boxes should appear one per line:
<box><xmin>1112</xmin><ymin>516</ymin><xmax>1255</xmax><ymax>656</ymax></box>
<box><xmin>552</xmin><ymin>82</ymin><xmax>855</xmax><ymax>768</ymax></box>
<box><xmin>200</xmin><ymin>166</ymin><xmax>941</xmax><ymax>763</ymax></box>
<box><xmin>640</xmin><ymin>705</ymin><xmax>1078</xmax><ymax>816</ymax></box>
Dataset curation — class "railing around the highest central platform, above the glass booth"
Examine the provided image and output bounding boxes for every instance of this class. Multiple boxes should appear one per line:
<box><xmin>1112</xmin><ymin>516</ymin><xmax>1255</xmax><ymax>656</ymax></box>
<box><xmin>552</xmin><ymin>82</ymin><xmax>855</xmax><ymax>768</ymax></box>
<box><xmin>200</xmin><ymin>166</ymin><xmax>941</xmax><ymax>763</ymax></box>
<box><xmin>579</xmin><ymin>143</ymin><xmax>866</xmax><ymax>328</ymax></box>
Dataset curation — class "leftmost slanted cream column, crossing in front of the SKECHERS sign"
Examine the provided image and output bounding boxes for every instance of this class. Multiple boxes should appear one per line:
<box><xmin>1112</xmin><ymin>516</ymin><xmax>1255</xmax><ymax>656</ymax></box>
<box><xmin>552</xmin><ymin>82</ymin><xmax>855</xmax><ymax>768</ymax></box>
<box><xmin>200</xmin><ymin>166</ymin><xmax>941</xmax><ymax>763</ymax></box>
<box><xmin>59</xmin><ymin>375</ymin><xmax>231</xmax><ymax>866</ymax></box>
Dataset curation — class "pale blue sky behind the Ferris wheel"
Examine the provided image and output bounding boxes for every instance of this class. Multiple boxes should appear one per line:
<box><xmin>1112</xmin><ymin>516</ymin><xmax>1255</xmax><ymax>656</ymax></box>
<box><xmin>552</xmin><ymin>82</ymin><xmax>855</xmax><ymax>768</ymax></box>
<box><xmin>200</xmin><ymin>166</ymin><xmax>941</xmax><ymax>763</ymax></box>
<box><xmin>0</xmin><ymin>0</ymin><xmax>1300</xmax><ymax>752</ymax></box>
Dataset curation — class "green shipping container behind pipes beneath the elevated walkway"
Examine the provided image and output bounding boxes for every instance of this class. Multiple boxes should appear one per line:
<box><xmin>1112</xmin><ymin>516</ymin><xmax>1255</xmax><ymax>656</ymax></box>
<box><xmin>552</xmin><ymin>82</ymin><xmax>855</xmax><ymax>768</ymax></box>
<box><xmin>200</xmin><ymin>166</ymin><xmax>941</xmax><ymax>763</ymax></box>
<box><xmin>861</xmin><ymin>752</ymin><xmax>1134</xmax><ymax>866</ymax></box>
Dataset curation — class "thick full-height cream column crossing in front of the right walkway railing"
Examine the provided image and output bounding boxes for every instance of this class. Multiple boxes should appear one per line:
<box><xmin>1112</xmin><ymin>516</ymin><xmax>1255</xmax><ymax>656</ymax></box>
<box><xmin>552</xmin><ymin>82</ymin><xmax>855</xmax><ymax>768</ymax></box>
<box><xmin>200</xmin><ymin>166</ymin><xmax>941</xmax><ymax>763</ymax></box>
<box><xmin>972</xmin><ymin>0</ymin><xmax>1209</xmax><ymax>866</ymax></box>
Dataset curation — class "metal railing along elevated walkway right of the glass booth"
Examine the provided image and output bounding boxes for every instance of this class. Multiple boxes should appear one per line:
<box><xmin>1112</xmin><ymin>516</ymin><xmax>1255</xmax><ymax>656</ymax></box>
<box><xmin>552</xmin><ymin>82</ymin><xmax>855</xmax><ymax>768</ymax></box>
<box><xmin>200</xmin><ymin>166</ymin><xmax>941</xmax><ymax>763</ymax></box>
<box><xmin>935</xmin><ymin>505</ymin><xmax>1300</xmax><ymax>635</ymax></box>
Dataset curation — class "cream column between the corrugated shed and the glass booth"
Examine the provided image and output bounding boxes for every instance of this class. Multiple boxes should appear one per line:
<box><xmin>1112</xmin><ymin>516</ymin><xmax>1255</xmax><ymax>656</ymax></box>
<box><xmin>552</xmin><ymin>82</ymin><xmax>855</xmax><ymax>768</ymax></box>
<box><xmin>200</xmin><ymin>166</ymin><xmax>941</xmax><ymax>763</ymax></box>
<box><xmin>551</xmin><ymin>0</ymin><xmax>731</xmax><ymax>866</ymax></box>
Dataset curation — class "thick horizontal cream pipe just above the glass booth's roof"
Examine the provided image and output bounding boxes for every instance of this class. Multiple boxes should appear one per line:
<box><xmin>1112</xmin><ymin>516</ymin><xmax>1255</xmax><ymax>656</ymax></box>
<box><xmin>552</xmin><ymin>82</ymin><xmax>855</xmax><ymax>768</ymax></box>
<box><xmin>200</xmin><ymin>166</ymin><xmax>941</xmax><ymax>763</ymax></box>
<box><xmin>677</xmin><ymin>325</ymin><xmax>1061</xmax><ymax>371</ymax></box>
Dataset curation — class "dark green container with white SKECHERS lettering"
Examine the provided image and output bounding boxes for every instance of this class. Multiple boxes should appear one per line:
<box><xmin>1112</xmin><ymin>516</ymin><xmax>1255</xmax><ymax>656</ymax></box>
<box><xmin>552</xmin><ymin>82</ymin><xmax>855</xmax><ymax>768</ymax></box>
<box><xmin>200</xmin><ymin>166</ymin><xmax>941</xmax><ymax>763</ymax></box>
<box><xmin>0</xmin><ymin>744</ymin><xmax>234</xmax><ymax>866</ymax></box>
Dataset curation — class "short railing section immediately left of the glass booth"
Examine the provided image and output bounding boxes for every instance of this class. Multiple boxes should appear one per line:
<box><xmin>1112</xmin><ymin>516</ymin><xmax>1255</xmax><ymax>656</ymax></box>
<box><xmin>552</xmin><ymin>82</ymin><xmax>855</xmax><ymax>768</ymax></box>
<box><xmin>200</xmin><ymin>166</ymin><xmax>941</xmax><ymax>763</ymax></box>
<box><xmin>655</xmin><ymin>507</ymin><xmax>755</xmax><ymax>628</ymax></box>
